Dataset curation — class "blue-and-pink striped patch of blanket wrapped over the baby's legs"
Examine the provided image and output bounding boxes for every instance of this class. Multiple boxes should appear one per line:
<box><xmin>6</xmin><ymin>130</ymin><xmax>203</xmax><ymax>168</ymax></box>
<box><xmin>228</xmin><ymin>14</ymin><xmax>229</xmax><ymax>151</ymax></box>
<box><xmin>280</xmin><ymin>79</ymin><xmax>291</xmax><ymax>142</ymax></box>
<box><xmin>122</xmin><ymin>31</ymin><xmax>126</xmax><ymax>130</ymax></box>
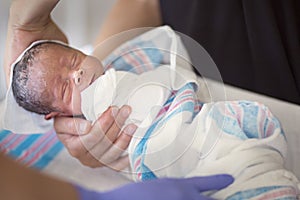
<box><xmin>209</xmin><ymin>101</ymin><xmax>284</xmax><ymax>140</ymax></box>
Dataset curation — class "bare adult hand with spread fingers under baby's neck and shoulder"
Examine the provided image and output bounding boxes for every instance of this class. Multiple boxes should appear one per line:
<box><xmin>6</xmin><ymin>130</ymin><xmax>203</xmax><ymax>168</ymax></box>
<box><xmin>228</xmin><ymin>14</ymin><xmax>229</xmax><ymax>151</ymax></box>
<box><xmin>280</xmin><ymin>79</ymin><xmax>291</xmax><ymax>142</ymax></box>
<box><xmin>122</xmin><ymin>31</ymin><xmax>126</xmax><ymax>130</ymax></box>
<box><xmin>54</xmin><ymin>106</ymin><xmax>136</xmax><ymax>170</ymax></box>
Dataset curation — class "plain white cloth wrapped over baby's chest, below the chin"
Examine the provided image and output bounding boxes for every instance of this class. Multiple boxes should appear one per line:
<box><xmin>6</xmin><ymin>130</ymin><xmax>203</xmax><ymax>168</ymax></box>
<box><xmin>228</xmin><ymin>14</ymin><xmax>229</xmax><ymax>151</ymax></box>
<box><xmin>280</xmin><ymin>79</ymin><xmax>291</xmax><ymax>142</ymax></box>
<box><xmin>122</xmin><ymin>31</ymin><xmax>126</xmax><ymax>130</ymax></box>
<box><xmin>81</xmin><ymin>65</ymin><xmax>196</xmax><ymax>130</ymax></box>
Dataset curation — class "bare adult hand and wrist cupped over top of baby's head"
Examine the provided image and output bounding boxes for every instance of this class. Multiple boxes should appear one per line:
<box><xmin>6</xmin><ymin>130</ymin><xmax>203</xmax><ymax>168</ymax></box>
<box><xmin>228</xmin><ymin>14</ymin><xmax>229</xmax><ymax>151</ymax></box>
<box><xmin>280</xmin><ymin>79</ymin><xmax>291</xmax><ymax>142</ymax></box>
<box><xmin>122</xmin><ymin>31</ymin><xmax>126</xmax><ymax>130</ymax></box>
<box><xmin>4</xmin><ymin>0</ymin><xmax>67</xmax><ymax>85</ymax></box>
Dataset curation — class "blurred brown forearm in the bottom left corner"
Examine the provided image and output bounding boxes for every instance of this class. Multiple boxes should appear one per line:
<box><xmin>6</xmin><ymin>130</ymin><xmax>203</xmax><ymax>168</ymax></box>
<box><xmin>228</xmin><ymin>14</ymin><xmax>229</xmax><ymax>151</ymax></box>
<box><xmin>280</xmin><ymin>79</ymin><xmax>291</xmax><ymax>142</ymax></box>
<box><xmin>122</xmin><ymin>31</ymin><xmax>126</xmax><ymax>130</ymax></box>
<box><xmin>0</xmin><ymin>152</ymin><xmax>78</xmax><ymax>200</ymax></box>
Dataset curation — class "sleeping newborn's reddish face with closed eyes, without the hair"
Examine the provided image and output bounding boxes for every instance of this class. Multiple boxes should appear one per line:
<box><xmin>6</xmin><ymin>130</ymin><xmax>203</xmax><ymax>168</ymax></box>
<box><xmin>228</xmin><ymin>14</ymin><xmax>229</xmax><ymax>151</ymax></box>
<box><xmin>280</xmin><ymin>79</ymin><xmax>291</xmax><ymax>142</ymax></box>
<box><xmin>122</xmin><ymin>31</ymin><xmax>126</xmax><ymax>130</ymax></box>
<box><xmin>30</xmin><ymin>45</ymin><xmax>103</xmax><ymax>119</ymax></box>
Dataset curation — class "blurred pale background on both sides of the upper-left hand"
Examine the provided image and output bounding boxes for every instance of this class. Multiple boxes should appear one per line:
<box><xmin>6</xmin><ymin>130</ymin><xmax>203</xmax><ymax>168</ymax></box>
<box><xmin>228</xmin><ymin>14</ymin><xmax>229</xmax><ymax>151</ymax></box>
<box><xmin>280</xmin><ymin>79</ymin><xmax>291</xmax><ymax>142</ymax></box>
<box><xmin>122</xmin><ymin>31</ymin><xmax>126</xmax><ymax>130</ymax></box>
<box><xmin>0</xmin><ymin>0</ymin><xmax>116</xmax><ymax>100</ymax></box>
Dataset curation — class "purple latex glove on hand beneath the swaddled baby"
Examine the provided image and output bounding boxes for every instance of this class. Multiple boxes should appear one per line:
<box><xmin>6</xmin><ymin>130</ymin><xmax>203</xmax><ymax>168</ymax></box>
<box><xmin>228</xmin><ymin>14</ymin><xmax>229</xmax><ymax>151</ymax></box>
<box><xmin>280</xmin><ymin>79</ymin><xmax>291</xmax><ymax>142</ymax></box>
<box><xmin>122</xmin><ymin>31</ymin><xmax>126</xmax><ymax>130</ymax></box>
<box><xmin>76</xmin><ymin>175</ymin><xmax>234</xmax><ymax>200</ymax></box>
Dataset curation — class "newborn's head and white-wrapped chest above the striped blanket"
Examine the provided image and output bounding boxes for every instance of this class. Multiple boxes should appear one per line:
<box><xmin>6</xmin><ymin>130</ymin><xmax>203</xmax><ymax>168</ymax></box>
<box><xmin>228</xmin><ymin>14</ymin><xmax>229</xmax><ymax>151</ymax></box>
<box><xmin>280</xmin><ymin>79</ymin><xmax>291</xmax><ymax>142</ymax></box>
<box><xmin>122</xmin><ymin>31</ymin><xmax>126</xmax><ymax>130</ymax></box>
<box><xmin>12</xmin><ymin>41</ymin><xmax>196</xmax><ymax>130</ymax></box>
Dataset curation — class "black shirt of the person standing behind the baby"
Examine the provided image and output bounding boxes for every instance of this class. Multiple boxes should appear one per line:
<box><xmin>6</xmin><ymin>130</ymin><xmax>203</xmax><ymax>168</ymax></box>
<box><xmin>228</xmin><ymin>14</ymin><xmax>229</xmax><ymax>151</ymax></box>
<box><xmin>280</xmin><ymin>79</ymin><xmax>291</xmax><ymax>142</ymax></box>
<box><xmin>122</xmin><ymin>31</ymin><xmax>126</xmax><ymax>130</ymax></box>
<box><xmin>160</xmin><ymin>0</ymin><xmax>300</xmax><ymax>104</ymax></box>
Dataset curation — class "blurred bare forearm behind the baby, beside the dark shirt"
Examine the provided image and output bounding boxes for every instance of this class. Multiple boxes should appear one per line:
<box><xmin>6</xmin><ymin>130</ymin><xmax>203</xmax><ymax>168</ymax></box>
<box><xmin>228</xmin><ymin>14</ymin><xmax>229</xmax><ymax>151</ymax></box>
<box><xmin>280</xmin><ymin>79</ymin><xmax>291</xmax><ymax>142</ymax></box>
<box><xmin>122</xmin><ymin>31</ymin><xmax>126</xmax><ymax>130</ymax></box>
<box><xmin>93</xmin><ymin>0</ymin><xmax>162</xmax><ymax>60</ymax></box>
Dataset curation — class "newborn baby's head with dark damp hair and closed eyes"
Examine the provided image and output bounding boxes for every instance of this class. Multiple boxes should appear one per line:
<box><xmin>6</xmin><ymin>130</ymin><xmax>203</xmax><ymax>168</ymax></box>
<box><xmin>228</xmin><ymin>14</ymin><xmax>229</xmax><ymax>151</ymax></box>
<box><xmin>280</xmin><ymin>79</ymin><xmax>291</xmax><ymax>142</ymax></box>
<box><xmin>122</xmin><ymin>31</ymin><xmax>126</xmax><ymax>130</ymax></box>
<box><xmin>12</xmin><ymin>41</ymin><xmax>103</xmax><ymax>119</ymax></box>
